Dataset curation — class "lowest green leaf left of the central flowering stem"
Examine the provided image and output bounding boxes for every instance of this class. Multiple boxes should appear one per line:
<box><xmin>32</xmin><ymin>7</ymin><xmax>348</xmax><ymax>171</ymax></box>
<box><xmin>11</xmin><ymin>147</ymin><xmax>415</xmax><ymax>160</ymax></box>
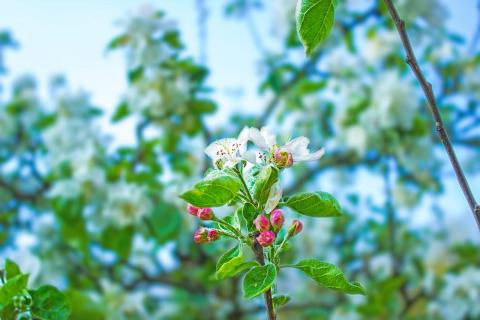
<box><xmin>243</xmin><ymin>263</ymin><xmax>277</xmax><ymax>299</ymax></box>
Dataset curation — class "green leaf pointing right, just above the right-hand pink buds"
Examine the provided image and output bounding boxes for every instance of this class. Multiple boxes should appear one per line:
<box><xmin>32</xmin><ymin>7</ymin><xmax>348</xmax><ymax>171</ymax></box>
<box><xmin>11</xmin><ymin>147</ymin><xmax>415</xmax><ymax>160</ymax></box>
<box><xmin>285</xmin><ymin>192</ymin><xmax>342</xmax><ymax>218</ymax></box>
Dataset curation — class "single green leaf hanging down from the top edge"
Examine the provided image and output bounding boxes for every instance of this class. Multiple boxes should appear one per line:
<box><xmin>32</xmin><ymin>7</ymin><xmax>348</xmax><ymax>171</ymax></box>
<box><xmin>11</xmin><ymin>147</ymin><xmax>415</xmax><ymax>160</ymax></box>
<box><xmin>295</xmin><ymin>0</ymin><xmax>335</xmax><ymax>56</ymax></box>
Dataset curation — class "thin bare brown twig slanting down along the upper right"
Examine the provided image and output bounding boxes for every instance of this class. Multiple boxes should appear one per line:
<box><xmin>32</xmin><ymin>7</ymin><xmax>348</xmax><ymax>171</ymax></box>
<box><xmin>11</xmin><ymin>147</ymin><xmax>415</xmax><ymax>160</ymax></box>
<box><xmin>384</xmin><ymin>0</ymin><xmax>480</xmax><ymax>229</ymax></box>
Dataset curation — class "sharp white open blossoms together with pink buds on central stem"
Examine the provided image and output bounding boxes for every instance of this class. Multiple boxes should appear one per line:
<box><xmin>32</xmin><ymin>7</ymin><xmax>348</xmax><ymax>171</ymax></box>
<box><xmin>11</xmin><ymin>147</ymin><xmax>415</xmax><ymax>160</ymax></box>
<box><xmin>187</xmin><ymin>127</ymin><xmax>318</xmax><ymax>247</ymax></box>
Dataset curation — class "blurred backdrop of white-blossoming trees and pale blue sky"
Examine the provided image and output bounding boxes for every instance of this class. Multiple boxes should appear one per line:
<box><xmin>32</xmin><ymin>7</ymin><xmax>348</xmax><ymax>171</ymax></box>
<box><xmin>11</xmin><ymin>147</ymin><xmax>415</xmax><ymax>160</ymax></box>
<box><xmin>0</xmin><ymin>0</ymin><xmax>480</xmax><ymax>320</ymax></box>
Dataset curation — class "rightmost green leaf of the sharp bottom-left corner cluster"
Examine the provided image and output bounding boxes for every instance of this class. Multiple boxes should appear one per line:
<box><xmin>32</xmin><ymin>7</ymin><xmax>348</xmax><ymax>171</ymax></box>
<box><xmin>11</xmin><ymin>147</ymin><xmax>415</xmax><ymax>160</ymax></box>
<box><xmin>31</xmin><ymin>285</ymin><xmax>70</xmax><ymax>320</ymax></box>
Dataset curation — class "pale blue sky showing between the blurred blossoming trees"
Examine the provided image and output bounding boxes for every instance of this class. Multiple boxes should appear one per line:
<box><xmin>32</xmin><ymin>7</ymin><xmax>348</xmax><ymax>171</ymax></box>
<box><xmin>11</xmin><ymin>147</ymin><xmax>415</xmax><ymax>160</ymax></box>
<box><xmin>0</xmin><ymin>0</ymin><xmax>480</xmax><ymax>238</ymax></box>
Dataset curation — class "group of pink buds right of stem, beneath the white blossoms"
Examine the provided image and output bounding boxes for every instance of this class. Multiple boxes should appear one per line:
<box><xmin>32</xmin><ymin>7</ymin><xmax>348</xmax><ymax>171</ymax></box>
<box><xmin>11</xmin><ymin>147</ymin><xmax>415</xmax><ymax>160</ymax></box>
<box><xmin>253</xmin><ymin>209</ymin><xmax>303</xmax><ymax>247</ymax></box>
